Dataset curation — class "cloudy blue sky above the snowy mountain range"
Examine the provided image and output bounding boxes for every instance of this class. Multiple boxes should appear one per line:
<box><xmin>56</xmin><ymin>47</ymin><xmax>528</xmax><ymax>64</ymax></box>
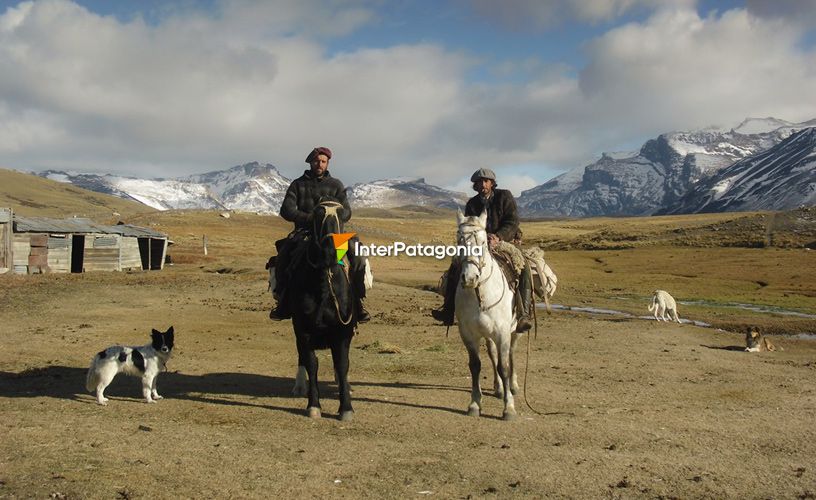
<box><xmin>0</xmin><ymin>0</ymin><xmax>816</xmax><ymax>195</ymax></box>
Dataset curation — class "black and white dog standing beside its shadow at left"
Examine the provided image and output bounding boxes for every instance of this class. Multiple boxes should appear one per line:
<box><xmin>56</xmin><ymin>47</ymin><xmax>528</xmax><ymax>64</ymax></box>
<box><xmin>85</xmin><ymin>326</ymin><xmax>173</xmax><ymax>405</ymax></box>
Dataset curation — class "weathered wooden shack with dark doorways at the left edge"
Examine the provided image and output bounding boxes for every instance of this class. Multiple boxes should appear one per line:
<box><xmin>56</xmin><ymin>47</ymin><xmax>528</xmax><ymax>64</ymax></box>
<box><xmin>0</xmin><ymin>209</ymin><xmax>168</xmax><ymax>274</ymax></box>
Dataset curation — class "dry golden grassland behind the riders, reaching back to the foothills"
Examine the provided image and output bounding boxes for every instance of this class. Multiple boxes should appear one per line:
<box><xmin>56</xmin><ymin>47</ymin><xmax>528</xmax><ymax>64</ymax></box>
<box><xmin>119</xmin><ymin>209</ymin><xmax>816</xmax><ymax>333</ymax></box>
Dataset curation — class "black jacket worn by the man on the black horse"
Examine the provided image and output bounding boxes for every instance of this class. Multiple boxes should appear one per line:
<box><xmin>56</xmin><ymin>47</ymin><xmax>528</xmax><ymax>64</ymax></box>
<box><xmin>280</xmin><ymin>170</ymin><xmax>351</xmax><ymax>229</ymax></box>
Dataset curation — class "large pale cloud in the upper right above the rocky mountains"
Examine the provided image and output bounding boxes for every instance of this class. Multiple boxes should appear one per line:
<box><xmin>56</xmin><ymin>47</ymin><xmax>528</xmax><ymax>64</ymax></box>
<box><xmin>580</xmin><ymin>9</ymin><xmax>816</xmax><ymax>130</ymax></box>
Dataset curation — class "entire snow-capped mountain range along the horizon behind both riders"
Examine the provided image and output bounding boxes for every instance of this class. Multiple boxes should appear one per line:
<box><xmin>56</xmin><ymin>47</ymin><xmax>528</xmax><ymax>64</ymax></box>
<box><xmin>28</xmin><ymin>118</ymin><xmax>816</xmax><ymax>217</ymax></box>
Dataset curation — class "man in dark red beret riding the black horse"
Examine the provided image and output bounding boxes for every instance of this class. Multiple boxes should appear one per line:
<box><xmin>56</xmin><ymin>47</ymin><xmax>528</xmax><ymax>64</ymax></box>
<box><xmin>269</xmin><ymin>147</ymin><xmax>371</xmax><ymax>323</ymax></box>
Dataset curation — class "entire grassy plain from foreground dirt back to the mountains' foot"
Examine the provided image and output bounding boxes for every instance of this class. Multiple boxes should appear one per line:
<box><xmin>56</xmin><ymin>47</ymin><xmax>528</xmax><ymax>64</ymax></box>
<box><xmin>0</xmin><ymin>190</ymin><xmax>816</xmax><ymax>498</ymax></box>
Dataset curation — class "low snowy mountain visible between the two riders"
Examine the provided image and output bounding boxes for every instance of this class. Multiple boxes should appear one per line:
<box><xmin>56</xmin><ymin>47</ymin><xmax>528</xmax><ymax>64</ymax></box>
<box><xmin>348</xmin><ymin>177</ymin><xmax>468</xmax><ymax>208</ymax></box>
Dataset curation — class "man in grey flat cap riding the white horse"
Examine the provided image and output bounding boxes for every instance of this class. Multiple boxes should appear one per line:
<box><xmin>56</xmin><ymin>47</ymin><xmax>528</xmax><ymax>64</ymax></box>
<box><xmin>431</xmin><ymin>168</ymin><xmax>533</xmax><ymax>333</ymax></box>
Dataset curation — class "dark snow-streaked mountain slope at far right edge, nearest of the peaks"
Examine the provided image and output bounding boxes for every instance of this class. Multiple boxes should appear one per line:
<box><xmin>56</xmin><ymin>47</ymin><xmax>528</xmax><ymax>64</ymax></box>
<box><xmin>665</xmin><ymin>128</ymin><xmax>816</xmax><ymax>214</ymax></box>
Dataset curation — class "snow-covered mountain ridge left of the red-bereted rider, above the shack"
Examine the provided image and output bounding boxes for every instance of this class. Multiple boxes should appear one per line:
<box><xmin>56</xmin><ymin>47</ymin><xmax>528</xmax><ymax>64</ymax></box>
<box><xmin>39</xmin><ymin>162</ymin><xmax>290</xmax><ymax>214</ymax></box>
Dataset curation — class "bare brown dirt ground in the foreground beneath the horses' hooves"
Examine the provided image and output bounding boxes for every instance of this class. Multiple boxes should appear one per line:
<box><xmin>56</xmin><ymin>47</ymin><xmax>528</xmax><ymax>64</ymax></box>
<box><xmin>0</xmin><ymin>258</ymin><xmax>816</xmax><ymax>498</ymax></box>
